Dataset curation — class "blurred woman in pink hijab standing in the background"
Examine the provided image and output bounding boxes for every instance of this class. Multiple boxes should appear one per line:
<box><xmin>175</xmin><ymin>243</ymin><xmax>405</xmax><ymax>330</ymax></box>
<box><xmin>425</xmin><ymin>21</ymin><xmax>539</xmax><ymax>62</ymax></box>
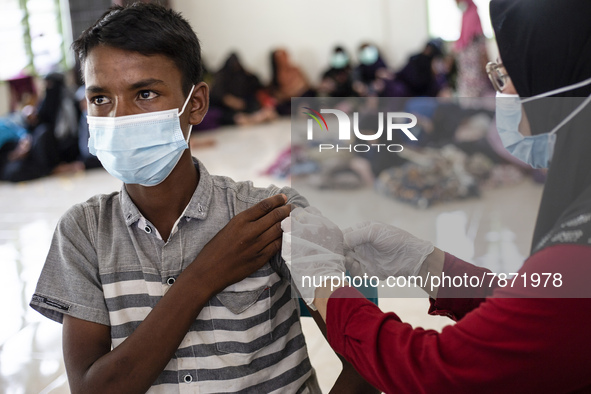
<box><xmin>454</xmin><ymin>0</ymin><xmax>494</xmax><ymax>97</ymax></box>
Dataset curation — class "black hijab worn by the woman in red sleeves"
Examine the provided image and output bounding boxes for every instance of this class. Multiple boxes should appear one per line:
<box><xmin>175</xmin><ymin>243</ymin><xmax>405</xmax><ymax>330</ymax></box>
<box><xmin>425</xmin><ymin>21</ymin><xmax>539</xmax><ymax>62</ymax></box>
<box><xmin>490</xmin><ymin>0</ymin><xmax>591</xmax><ymax>251</ymax></box>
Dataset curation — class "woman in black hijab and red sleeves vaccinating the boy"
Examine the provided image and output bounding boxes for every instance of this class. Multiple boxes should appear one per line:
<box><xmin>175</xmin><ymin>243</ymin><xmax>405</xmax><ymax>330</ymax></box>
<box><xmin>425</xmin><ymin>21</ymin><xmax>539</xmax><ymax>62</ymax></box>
<box><xmin>282</xmin><ymin>0</ymin><xmax>591</xmax><ymax>393</ymax></box>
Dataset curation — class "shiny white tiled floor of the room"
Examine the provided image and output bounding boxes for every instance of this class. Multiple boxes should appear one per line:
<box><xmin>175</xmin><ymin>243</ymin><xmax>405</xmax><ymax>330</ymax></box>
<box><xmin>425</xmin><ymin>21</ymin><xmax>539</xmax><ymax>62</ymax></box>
<box><xmin>0</xmin><ymin>120</ymin><xmax>542</xmax><ymax>394</ymax></box>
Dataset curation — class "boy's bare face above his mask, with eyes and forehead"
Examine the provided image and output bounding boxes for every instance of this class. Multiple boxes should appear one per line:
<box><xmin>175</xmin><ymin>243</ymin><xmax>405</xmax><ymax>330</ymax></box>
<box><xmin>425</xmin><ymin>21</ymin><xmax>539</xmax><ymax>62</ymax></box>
<box><xmin>84</xmin><ymin>45</ymin><xmax>191</xmax><ymax>136</ymax></box>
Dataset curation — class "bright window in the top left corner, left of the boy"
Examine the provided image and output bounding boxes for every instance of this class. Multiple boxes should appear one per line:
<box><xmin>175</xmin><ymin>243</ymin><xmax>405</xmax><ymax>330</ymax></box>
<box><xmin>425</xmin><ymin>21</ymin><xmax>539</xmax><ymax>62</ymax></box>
<box><xmin>0</xmin><ymin>0</ymin><xmax>72</xmax><ymax>80</ymax></box>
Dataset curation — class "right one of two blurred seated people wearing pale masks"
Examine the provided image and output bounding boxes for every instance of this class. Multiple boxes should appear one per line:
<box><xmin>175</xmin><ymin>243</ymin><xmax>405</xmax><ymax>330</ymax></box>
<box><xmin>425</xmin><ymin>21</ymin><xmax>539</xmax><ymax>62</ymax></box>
<box><xmin>353</xmin><ymin>43</ymin><xmax>392</xmax><ymax>97</ymax></box>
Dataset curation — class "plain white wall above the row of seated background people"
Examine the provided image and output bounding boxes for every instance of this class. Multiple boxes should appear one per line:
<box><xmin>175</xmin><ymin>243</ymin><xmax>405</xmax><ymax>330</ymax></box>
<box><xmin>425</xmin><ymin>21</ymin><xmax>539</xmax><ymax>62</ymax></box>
<box><xmin>172</xmin><ymin>0</ymin><xmax>428</xmax><ymax>82</ymax></box>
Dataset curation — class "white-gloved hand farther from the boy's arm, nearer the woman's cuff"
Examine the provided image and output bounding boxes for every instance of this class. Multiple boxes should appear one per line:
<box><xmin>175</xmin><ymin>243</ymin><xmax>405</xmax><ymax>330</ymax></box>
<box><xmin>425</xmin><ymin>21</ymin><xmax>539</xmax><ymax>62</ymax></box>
<box><xmin>343</xmin><ymin>222</ymin><xmax>434</xmax><ymax>280</ymax></box>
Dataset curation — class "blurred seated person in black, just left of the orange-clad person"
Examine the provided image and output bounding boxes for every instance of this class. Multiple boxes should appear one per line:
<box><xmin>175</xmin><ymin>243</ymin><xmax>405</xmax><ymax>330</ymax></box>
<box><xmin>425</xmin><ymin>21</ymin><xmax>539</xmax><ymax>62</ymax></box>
<box><xmin>211</xmin><ymin>53</ymin><xmax>276</xmax><ymax>125</ymax></box>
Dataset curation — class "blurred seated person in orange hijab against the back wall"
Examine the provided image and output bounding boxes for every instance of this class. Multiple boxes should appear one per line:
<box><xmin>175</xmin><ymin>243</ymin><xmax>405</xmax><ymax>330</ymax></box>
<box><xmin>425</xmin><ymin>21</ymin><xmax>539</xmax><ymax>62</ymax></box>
<box><xmin>269</xmin><ymin>49</ymin><xmax>316</xmax><ymax>115</ymax></box>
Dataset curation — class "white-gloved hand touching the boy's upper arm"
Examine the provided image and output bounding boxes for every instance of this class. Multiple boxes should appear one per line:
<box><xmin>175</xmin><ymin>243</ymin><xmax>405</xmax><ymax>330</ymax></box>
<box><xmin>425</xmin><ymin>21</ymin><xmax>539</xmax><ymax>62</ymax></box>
<box><xmin>281</xmin><ymin>207</ymin><xmax>345</xmax><ymax>310</ymax></box>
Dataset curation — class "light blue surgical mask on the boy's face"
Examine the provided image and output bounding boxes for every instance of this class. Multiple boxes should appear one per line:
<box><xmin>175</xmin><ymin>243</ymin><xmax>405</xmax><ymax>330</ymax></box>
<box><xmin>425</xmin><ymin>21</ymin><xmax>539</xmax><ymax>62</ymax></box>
<box><xmin>87</xmin><ymin>86</ymin><xmax>195</xmax><ymax>186</ymax></box>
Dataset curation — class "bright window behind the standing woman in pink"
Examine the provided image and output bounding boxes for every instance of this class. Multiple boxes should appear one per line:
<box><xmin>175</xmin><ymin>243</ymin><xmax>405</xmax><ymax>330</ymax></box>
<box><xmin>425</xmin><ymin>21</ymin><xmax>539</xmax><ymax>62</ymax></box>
<box><xmin>428</xmin><ymin>0</ymin><xmax>494</xmax><ymax>41</ymax></box>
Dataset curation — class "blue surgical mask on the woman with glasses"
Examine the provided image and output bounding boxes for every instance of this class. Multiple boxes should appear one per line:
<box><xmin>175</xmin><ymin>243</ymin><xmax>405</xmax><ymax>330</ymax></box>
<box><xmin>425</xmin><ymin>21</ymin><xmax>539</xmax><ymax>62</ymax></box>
<box><xmin>496</xmin><ymin>79</ymin><xmax>591</xmax><ymax>168</ymax></box>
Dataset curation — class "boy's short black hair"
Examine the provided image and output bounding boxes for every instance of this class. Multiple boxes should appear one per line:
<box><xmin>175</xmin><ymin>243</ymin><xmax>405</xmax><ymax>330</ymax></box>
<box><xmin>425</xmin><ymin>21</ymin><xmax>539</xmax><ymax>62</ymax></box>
<box><xmin>72</xmin><ymin>3</ymin><xmax>203</xmax><ymax>94</ymax></box>
